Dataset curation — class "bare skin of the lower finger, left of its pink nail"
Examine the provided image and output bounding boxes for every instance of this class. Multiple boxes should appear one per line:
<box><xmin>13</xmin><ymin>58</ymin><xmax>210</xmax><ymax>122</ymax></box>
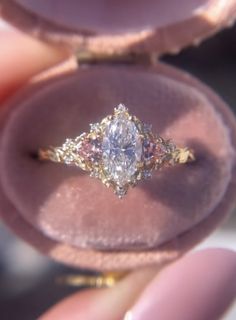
<box><xmin>39</xmin><ymin>268</ymin><xmax>156</xmax><ymax>320</ymax></box>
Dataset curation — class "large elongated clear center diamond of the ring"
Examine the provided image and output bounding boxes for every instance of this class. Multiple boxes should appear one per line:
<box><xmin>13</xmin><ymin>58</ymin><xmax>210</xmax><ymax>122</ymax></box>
<box><xmin>102</xmin><ymin>106</ymin><xmax>142</xmax><ymax>187</ymax></box>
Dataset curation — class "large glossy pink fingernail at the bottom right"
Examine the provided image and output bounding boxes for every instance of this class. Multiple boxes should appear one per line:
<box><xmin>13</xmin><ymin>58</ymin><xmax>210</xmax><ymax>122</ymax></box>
<box><xmin>128</xmin><ymin>249</ymin><xmax>236</xmax><ymax>320</ymax></box>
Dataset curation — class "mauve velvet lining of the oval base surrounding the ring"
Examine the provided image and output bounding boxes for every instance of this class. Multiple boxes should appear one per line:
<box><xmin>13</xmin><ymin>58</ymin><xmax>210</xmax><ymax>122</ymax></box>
<box><xmin>0</xmin><ymin>67</ymin><xmax>234</xmax><ymax>251</ymax></box>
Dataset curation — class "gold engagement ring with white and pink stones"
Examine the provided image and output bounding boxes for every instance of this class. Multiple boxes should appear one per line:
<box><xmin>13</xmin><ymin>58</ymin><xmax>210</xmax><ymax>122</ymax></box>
<box><xmin>39</xmin><ymin>104</ymin><xmax>195</xmax><ymax>198</ymax></box>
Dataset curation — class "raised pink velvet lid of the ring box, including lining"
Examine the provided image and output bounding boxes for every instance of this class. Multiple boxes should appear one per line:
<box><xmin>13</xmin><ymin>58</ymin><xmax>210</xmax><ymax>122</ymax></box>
<box><xmin>0</xmin><ymin>0</ymin><xmax>236</xmax><ymax>56</ymax></box>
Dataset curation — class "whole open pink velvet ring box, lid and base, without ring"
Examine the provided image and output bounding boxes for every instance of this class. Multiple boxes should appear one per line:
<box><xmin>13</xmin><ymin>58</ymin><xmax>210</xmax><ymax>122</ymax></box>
<box><xmin>0</xmin><ymin>0</ymin><xmax>236</xmax><ymax>271</ymax></box>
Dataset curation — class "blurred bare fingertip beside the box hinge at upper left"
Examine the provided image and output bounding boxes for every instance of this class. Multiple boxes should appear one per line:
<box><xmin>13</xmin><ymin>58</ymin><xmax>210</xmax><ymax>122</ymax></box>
<box><xmin>0</xmin><ymin>31</ymin><xmax>68</xmax><ymax>100</ymax></box>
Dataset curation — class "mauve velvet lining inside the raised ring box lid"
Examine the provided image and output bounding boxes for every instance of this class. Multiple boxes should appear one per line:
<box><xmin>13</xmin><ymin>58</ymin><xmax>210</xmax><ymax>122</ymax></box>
<box><xmin>15</xmin><ymin>0</ymin><xmax>209</xmax><ymax>34</ymax></box>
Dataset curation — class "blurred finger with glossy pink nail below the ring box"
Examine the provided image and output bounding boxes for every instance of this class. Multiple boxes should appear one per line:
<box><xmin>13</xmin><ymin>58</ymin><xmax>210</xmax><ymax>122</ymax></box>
<box><xmin>40</xmin><ymin>249</ymin><xmax>236</xmax><ymax>320</ymax></box>
